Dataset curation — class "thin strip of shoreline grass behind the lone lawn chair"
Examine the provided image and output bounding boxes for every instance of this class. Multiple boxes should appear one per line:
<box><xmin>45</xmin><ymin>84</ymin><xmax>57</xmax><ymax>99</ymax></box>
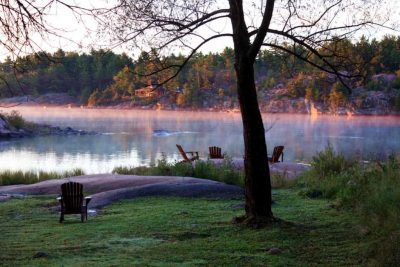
<box><xmin>0</xmin><ymin>169</ymin><xmax>85</xmax><ymax>186</ymax></box>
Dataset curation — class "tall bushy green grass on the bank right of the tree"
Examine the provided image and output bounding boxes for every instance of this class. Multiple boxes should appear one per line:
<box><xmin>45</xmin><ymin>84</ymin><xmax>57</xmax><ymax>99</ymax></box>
<box><xmin>298</xmin><ymin>147</ymin><xmax>400</xmax><ymax>266</ymax></box>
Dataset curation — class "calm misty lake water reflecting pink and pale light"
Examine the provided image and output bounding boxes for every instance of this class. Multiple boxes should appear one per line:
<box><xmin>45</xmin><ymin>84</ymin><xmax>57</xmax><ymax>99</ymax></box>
<box><xmin>0</xmin><ymin>108</ymin><xmax>400</xmax><ymax>173</ymax></box>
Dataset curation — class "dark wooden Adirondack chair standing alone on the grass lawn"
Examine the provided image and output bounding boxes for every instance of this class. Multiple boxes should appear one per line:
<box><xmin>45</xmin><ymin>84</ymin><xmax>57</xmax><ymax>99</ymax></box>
<box><xmin>57</xmin><ymin>182</ymin><xmax>92</xmax><ymax>223</ymax></box>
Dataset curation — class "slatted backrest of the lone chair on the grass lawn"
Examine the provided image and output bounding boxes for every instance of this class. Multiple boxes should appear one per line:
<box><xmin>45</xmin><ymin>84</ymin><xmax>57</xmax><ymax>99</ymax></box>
<box><xmin>61</xmin><ymin>182</ymin><xmax>83</xmax><ymax>212</ymax></box>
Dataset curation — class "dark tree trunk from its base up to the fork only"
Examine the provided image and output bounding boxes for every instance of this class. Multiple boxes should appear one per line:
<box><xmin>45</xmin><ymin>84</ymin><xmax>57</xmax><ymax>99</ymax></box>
<box><xmin>236</xmin><ymin>56</ymin><xmax>273</xmax><ymax>221</ymax></box>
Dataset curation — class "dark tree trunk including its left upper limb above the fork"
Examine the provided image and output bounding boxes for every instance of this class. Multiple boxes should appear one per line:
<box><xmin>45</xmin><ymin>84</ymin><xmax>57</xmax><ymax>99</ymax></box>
<box><xmin>229</xmin><ymin>0</ymin><xmax>273</xmax><ymax>222</ymax></box>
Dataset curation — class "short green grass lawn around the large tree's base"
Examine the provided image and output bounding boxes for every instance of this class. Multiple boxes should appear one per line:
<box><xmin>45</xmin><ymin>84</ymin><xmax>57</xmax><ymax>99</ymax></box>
<box><xmin>0</xmin><ymin>189</ymin><xmax>370</xmax><ymax>266</ymax></box>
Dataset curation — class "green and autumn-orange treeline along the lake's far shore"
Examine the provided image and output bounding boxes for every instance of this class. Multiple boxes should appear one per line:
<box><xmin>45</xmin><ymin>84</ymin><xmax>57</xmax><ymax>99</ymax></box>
<box><xmin>0</xmin><ymin>36</ymin><xmax>400</xmax><ymax>110</ymax></box>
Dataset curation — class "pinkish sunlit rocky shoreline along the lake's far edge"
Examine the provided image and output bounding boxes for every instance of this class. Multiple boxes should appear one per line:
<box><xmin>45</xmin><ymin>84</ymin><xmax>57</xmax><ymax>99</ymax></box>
<box><xmin>0</xmin><ymin>91</ymin><xmax>400</xmax><ymax>115</ymax></box>
